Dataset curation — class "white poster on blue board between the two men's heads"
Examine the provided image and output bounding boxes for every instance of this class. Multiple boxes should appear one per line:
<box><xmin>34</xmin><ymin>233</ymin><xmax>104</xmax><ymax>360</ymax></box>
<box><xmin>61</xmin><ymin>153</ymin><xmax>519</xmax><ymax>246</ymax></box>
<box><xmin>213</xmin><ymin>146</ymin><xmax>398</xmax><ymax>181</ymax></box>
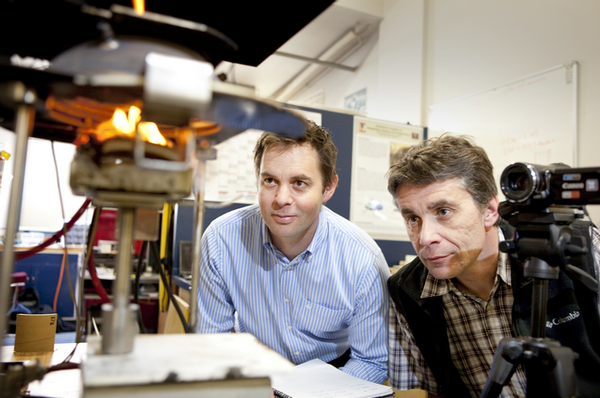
<box><xmin>350</xmin><ymin>117</ymin><xmax>424</xmax><ymax>241</ymax></box>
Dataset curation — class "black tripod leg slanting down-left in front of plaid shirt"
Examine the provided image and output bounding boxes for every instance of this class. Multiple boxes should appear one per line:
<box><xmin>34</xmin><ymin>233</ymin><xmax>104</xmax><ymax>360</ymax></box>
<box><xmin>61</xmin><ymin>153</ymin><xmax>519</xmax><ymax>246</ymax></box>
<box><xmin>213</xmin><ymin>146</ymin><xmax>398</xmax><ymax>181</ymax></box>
<box><xmin>479</xmin><ymin>337</ymin><xmax>523</xmax><ymax>398</ymax></box>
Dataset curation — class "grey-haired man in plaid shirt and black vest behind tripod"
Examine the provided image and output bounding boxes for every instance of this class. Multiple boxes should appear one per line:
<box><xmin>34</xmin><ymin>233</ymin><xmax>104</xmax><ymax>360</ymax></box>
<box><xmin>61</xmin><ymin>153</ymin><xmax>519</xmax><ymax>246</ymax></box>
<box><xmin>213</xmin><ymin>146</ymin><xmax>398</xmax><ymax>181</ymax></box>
<box><xmin>388</xmin><ymin>134</ymin><xmax>600</xmax><ymax>398</ymax></box>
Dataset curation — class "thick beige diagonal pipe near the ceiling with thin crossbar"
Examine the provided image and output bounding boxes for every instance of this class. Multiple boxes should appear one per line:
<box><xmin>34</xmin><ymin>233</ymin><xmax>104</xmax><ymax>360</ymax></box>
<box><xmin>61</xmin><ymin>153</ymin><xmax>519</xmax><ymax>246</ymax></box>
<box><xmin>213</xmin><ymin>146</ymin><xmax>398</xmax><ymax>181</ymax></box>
<box><xmin>270</xmin><ymin>23</ymin><xmax>375</xmax><ymax>102</ymax></box>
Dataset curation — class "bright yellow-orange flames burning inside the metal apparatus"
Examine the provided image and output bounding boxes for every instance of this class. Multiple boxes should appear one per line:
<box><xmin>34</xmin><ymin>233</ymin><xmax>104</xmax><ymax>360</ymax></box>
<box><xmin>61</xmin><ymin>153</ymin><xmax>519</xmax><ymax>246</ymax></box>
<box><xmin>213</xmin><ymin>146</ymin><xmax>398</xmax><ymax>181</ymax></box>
<box><xmin>96</xmin><ymin>106</ymin><xmax>173</xmax><ymax>147</ymax></box>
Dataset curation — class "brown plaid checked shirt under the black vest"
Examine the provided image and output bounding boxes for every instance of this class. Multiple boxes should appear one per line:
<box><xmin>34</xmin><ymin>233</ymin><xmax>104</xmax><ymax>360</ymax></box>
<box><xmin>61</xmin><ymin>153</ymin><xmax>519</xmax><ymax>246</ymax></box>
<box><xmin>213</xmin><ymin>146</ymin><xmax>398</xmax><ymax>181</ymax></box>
<box><xmin>388</xmin><ymin>228</ymin><xmax>600</xmax><ymax>398</ymax></box>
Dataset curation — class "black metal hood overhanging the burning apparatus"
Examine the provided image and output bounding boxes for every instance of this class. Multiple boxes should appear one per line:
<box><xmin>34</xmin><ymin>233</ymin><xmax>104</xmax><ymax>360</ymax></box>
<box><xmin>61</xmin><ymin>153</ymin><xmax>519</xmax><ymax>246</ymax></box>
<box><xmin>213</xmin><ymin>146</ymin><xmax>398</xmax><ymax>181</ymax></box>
<box><xmin>0</xmin><ymin>0</ymin><xmax>334</xmax><ymax>66</ymax></box>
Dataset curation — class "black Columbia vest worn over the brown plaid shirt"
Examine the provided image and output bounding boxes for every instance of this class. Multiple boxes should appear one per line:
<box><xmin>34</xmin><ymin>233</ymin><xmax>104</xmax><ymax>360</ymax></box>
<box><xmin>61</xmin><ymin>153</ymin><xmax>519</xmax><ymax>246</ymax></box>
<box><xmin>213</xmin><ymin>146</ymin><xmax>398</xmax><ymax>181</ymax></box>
<box><xmin>388</xmin><ymin>221</ymin><xmax>600</xmax><ymax>398</ymax></box>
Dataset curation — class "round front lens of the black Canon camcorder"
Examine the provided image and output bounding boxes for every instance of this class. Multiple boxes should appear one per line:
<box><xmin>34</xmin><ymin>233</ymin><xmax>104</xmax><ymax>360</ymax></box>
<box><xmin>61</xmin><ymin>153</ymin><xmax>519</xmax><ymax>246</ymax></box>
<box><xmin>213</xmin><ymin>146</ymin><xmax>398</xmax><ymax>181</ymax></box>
<box><xmin>500</xmin><ymin>163</ymin><xmax>539</xmax><ymax>203</ymax></box>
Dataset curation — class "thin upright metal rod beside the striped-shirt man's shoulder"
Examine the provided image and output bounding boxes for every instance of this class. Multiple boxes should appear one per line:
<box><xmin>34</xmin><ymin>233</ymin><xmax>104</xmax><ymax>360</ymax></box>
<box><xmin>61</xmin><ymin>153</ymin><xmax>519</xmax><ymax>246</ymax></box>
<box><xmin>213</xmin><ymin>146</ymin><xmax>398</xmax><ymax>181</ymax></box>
<box><xmin>188</xmin><ymin>154</ymin><xmax>206</xmax><ymax>332</ymax></box>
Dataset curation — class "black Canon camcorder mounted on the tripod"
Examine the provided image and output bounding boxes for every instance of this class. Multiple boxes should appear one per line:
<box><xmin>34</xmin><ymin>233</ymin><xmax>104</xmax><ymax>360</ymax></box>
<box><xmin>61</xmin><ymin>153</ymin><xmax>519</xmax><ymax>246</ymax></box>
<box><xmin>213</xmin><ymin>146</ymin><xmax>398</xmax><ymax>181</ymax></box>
<box><xmin>500</xmin><ymin>162</ymin><xmax>600</xmax><ymax>209</ymax></box>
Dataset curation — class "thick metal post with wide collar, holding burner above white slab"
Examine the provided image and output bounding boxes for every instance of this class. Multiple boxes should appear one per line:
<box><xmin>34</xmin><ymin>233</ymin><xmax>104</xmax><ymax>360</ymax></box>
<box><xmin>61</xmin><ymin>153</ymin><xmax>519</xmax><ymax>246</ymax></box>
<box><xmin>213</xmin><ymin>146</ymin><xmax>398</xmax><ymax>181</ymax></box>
<box><xmin>102</xmin><ymin>207</ymin><xmax>137</xmax><ymax>354</ymax></box>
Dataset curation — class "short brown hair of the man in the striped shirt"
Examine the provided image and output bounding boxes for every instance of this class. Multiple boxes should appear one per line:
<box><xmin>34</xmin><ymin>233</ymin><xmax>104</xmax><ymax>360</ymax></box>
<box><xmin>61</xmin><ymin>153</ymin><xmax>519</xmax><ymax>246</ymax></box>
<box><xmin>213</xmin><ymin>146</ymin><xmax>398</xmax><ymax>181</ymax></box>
<box><xmin>254</xmin><ymin>120</ymin><xmax>337</xmax><ymax>189</ymax></box>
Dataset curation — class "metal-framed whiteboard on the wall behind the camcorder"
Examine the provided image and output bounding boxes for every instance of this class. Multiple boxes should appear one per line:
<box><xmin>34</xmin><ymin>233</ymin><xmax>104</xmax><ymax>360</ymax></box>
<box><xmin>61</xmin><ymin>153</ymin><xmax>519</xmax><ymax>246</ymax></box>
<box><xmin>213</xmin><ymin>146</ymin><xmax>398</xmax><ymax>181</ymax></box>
<box><xmin>428</xmin><ymin>61</ymin><xmax>578</xmax><ymax>200</ymax></box>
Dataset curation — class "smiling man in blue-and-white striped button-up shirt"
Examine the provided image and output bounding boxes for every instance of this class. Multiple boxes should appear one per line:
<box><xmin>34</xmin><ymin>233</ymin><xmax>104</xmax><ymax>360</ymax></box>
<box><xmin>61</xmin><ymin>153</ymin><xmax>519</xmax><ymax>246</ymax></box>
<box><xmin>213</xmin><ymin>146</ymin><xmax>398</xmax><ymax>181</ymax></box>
<box><xmin>197</xmin><ymin>121</ymin><xmax>389</xmax><ymax>383</ymax></box>
